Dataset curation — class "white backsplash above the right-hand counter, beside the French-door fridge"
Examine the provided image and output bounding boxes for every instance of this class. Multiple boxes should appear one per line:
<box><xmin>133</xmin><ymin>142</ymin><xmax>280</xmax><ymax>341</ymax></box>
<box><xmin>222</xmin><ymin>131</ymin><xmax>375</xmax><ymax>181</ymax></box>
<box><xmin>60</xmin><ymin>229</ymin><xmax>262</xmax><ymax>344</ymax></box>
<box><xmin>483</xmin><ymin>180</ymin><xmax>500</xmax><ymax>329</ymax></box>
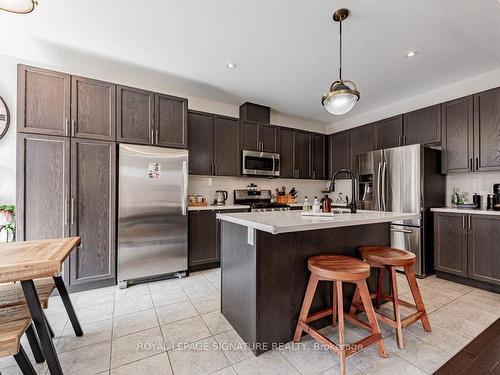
<box><xmin>446</xmin><ymin>172</ymin><xmax>500</xmax><ymax>208</ymax></box>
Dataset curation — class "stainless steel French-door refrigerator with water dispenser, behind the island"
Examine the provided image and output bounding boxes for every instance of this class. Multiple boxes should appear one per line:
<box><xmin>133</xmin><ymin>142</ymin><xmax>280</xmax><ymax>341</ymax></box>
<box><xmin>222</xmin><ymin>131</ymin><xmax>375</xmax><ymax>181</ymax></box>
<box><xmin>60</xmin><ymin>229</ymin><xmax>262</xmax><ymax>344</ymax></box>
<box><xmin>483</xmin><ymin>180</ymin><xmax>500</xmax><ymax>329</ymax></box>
<box><xmin>356</xmin><ymin>145</ymin><xmax>446</xmax><ymax>277</ymax></box>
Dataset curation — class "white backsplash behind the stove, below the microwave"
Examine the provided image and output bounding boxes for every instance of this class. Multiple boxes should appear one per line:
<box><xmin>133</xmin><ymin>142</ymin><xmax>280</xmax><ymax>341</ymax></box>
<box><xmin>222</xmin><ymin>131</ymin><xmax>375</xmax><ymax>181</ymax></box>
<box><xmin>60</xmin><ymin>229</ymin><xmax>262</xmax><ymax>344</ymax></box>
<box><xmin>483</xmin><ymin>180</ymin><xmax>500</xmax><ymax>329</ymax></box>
<box><xmin>188</xmin><ymin>176</ymin><xmax>351</xmax><ymax>204</ymax></box>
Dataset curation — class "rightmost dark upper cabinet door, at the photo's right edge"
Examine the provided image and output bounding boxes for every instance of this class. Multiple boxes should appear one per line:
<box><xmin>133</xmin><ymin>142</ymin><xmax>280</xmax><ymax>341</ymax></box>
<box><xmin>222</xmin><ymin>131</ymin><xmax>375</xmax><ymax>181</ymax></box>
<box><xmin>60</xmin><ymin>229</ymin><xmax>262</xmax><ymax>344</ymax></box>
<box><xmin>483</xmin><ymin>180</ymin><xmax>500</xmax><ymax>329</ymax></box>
<box><xmin>474</xmin><ymin>88</ymin><xmax>500</xmax><ymax>171</ymax></box>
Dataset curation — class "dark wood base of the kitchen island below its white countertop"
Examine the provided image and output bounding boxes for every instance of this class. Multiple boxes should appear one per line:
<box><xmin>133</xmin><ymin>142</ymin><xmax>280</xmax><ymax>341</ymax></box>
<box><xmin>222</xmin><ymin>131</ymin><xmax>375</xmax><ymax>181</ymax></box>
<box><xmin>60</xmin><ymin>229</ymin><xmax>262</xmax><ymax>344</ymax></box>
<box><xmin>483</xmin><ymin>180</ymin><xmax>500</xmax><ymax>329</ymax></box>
<box><xmin>221</xmin><ymin>221</ymin><xmax>390</xmax><ymax>355</ymax></box>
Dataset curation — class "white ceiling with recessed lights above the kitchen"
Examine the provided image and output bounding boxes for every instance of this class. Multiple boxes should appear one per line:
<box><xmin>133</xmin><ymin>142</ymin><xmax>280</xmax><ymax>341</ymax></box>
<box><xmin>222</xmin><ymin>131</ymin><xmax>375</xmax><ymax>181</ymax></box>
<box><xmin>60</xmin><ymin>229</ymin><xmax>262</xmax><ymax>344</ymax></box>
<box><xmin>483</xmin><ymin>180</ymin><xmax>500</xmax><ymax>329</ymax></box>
<box><xmin>0</xmin><ymin>0</ymin><xmax>500</xmax><ymax>129</ymax></box>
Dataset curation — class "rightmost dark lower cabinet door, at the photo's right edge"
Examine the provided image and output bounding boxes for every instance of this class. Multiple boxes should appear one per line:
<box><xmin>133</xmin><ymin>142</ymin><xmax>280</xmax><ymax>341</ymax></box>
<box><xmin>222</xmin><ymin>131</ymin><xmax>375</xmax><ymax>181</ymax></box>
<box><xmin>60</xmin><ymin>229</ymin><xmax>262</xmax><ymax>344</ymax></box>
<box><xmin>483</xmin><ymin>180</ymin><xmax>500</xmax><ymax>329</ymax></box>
<box><xmin>468</xmin><ymin>215</ymin><xmax>500</xmax><ymax>285</ymax></box>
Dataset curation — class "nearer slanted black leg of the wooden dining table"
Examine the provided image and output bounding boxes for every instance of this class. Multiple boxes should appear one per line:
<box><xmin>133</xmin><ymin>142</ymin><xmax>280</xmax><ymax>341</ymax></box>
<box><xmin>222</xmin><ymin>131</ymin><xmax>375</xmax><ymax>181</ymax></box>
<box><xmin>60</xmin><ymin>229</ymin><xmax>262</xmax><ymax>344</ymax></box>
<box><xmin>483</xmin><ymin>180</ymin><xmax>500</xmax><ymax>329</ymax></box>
<box><xmin>21</xmin><ymin>280</ymin><xmax>63</xmax><ymax>375</ymax></box>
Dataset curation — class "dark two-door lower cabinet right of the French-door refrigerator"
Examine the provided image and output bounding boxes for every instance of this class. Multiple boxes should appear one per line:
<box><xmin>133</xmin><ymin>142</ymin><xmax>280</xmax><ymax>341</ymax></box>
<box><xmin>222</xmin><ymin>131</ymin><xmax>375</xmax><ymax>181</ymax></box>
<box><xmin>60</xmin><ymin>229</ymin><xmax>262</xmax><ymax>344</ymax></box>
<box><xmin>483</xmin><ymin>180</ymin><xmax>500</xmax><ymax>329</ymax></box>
<box><xmin>434</xmin><ymin>212</ymin><xmax>500</xmax><ymax>290</ymax></box>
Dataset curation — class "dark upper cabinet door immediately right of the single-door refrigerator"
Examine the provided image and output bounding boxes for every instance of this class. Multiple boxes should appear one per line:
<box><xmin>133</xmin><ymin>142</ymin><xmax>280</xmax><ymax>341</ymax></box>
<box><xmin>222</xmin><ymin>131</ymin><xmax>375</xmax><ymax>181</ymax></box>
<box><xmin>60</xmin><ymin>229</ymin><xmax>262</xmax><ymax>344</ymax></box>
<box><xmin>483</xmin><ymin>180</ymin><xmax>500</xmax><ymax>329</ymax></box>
<box><xmin>188</xmin><ymin>111</ymin><xmax>214</xmax><ymax>175</ymax></box>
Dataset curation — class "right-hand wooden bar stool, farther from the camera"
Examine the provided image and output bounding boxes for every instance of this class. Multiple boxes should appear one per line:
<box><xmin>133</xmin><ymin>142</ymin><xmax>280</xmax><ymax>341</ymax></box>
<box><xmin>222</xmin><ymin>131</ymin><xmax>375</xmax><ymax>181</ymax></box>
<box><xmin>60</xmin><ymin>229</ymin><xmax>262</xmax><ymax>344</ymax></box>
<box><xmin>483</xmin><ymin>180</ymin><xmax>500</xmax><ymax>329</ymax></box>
<box><xmin>349</xmin><ymin>247</ymin><xmax>431</xmax><ymax>349</ymax></box>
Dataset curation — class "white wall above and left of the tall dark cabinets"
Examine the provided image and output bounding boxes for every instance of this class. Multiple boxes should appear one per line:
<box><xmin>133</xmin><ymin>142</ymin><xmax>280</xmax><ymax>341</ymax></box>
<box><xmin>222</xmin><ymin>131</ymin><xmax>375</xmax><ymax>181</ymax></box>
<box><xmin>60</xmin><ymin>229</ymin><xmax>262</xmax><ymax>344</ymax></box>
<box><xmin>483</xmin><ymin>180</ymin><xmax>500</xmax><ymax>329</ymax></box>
<box><xmin>0</xmin><ymin>55</ymin><xmax>325</xmax><ymax>204</ymax></box>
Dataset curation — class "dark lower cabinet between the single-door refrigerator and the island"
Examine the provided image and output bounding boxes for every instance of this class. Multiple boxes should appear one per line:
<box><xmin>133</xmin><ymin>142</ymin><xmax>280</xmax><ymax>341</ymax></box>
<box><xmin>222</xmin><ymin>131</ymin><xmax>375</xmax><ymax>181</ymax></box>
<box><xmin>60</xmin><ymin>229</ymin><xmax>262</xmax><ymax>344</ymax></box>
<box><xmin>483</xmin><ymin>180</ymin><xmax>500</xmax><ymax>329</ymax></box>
<box><xmin>188</xmin><ymin>209</ymin><xmax>247</xmax><ymax>271</ymax></box>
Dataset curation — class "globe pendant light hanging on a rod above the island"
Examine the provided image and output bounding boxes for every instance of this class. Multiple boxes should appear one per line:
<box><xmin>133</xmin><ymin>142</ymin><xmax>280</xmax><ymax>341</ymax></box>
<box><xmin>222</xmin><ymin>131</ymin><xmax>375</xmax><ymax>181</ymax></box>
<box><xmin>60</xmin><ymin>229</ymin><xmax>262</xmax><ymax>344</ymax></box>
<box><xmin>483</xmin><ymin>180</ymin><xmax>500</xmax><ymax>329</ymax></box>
<box><xmin>321</xmin><ymin>8</ymin><xmax>359</xmax><ymax>115</ymax></box>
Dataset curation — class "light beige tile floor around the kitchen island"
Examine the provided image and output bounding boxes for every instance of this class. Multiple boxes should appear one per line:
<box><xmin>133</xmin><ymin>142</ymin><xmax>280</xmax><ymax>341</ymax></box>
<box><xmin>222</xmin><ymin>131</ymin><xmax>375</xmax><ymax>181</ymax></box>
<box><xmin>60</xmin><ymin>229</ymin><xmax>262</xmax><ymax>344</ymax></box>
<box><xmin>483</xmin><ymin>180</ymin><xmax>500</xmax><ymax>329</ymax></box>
<box><xmin>0</xmin><ymin>269</ymin><xmax>500</xmax><ymax>375</ymax></box>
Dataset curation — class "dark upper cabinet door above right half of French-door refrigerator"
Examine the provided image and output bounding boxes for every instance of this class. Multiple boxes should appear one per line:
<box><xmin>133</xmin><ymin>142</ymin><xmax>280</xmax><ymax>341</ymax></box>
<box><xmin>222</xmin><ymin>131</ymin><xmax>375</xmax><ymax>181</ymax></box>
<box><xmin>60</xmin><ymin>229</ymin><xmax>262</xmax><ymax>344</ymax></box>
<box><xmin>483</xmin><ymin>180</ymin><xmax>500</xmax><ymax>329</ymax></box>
<box><xmin>403</xmin><ymin>104</ymin><xmax>441</xmax><ymax>145</ymax></box>
